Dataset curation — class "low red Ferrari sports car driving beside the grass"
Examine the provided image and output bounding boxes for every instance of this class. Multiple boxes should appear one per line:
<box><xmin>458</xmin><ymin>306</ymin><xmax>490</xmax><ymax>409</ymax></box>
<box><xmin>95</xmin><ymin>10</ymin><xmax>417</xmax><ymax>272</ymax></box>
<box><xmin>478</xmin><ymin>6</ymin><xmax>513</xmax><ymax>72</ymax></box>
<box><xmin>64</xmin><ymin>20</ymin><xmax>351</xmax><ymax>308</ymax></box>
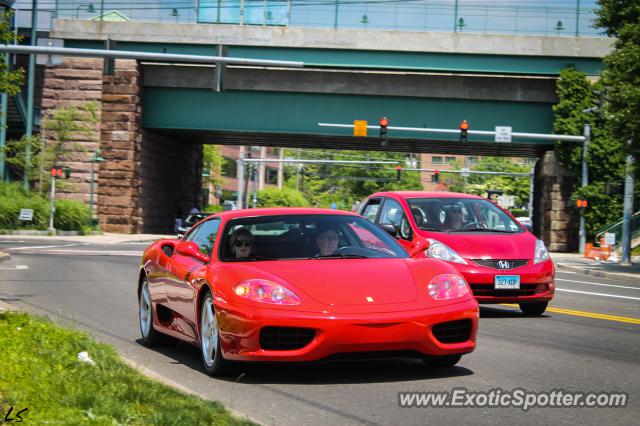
<box><xmin>138</xmin><ymin>208</ymin><xmax>478</xmax><ymax>374</ymax></box>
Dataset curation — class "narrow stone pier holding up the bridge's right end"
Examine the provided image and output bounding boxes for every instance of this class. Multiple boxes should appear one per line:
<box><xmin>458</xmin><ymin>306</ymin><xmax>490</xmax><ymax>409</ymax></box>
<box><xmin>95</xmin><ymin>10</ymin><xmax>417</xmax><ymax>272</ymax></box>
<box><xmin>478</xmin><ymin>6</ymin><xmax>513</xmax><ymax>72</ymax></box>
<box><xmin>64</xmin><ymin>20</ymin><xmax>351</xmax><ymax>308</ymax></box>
<box><xmin>534</xmin><ymin>151</ymin><xmax>578</xmax><ymax>252</ymax></box>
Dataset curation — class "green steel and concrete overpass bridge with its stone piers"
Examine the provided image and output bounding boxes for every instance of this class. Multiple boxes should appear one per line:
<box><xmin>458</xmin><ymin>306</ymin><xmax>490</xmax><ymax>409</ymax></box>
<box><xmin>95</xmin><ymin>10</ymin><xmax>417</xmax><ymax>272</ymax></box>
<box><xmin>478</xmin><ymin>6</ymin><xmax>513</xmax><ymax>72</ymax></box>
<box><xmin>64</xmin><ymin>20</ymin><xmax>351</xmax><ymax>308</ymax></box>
<box><xmin>26</xmin><ymin>19</ymin><xmax>612</xmax><ymax>250</ymax></box>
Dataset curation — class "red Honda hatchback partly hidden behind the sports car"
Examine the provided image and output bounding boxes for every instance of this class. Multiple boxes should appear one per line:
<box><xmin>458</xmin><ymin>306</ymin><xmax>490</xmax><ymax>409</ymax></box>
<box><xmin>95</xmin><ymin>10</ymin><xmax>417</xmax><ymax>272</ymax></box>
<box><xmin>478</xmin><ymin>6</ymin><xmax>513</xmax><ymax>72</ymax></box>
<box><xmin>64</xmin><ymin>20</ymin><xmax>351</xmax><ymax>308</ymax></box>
<box><xmin>358</xmin><ymin>191</ymin><xmax>555</xmax><ymax>315</ymax></box>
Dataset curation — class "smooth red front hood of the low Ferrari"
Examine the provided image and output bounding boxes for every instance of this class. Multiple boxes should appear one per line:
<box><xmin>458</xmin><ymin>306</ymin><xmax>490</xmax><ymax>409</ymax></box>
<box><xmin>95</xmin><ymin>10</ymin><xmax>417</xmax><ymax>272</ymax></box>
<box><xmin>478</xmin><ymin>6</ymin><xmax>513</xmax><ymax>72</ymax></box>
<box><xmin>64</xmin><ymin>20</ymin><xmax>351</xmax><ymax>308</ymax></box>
<box><xmin>252</xmin><ymin>259</ymin><xmax>418</xmax><ymax>307</ymax></box>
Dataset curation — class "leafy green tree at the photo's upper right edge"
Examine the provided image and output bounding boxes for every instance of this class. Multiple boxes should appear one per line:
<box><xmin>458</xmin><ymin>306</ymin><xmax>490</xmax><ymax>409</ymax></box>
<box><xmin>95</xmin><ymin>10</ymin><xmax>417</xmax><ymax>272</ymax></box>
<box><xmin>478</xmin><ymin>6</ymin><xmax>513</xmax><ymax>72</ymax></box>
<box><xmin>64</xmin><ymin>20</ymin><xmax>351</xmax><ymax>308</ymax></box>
<box><xmin>595</xmin><ymin>0</ymin><xmax>640</xmax><ymax>170</ymax></box>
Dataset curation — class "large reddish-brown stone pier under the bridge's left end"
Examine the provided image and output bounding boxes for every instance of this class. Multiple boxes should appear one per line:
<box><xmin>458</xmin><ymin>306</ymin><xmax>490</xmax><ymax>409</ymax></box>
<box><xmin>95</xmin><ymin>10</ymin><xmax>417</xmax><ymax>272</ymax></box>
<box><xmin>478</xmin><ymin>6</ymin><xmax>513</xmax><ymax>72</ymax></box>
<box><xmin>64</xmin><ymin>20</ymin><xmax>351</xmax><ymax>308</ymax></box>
<box><xmin>41</xmin><ymin>58</ymin><xmax>202</xmax><ymax>233</ymax></box>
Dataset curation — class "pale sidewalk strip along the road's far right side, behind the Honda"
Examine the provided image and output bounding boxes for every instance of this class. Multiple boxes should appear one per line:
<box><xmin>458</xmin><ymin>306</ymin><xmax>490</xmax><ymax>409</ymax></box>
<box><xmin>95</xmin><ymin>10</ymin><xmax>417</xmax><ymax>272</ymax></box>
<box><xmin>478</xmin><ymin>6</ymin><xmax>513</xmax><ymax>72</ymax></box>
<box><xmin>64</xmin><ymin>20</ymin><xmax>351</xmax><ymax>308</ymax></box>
<box><xmin>551</xmin><ymin>253</ymin><xmax>640</xmax><ymax>284</ymax></box>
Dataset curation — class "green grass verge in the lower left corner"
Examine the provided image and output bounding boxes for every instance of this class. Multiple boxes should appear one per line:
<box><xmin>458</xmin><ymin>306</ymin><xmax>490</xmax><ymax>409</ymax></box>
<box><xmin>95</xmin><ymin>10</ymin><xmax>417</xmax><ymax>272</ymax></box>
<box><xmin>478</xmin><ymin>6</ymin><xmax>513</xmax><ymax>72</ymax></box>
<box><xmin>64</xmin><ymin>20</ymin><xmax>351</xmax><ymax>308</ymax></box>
<box><xmin>0</xmin><ymin>312</ymin><xmax>253</xmax><ymax>425</ymax></box>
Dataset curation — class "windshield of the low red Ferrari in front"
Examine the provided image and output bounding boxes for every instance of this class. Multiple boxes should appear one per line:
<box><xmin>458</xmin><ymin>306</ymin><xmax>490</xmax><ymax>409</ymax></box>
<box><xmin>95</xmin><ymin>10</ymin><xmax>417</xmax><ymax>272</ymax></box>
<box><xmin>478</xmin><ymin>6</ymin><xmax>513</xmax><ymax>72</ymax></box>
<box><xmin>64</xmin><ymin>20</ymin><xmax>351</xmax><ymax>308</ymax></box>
<box><xmin>219</xmin><ymin>214</ymin><xmax>409</xmax><ymax>262</ymax></box>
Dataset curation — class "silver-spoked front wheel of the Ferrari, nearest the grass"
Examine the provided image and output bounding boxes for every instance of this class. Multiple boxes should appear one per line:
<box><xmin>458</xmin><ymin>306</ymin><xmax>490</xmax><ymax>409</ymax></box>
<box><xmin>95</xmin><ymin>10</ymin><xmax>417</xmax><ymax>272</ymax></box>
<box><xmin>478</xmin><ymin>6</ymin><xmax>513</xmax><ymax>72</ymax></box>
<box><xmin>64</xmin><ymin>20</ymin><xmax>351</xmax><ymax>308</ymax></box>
<box><xmin>200</xmin><ymin>290</ymin><xmax>227</xmax><ymax>375</ymax></box>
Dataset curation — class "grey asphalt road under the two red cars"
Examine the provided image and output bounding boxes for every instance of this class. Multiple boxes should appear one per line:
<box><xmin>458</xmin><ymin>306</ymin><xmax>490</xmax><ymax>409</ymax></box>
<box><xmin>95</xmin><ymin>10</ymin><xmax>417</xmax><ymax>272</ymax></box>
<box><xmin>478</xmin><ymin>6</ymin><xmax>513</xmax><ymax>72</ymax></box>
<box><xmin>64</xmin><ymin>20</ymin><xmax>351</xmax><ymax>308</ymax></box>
<box><xmin>0</xmin><ymin>237</ymin><xmax>640</xmax><ymax>425</ymax></box>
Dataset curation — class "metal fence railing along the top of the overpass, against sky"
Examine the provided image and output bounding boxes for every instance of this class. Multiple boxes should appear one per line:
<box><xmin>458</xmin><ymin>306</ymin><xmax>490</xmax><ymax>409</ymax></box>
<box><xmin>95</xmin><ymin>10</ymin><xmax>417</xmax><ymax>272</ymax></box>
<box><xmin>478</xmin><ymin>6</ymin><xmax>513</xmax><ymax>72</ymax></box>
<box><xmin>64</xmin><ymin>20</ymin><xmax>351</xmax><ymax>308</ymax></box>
<box><xmin>18</xmin><ymin>0</ymin><xmax>602</xmax><ymax>37</ymax></box>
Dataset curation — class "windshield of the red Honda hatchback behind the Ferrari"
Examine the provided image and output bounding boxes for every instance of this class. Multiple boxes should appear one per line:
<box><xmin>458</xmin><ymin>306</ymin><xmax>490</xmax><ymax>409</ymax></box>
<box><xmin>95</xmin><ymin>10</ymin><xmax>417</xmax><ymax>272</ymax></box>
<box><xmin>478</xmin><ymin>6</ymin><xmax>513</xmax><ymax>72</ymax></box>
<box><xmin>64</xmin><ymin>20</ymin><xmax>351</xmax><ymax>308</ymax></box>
<box><xmin>407</xmin><ymin>198</ymin><xmax>524</xmax><ymax>233</ymax></box>
